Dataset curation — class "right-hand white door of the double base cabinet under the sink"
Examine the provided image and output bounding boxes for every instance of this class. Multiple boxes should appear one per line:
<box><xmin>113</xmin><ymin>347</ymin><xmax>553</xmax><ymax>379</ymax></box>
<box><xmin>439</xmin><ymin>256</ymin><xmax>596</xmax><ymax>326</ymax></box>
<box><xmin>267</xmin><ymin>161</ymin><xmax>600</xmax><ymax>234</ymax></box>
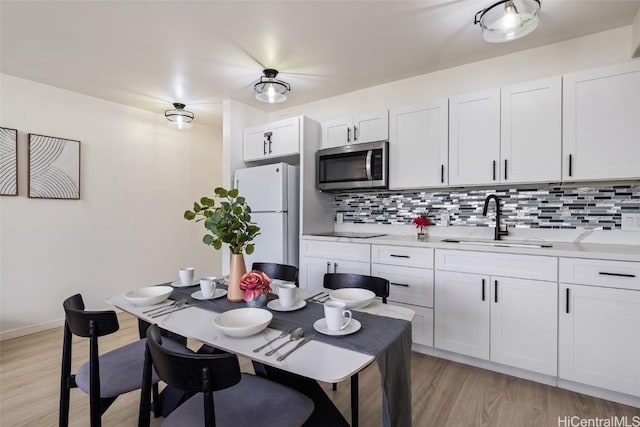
<box><xmin>491</xmin><ymin>277</ymin><xmax>558</xmax><ymax>376</ymax></box>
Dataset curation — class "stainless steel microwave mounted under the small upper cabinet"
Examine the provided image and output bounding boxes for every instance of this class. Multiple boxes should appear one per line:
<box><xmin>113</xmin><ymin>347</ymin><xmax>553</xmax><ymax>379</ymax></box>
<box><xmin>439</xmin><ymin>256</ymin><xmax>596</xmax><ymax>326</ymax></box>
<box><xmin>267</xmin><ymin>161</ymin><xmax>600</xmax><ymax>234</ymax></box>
<box><xmin>316</xmin><ymin>141</ymin><xmax>389</xmax><ymax>191</ymax></box>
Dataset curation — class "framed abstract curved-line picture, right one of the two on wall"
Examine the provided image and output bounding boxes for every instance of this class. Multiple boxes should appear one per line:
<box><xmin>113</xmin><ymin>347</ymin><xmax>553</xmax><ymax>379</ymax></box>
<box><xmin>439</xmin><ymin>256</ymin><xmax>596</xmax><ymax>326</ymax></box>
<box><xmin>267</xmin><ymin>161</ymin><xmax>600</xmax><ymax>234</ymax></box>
<box><xmin>29</xmin><ymin>133</ymin><xmax>80</xmax><ymax>200</ymax></box>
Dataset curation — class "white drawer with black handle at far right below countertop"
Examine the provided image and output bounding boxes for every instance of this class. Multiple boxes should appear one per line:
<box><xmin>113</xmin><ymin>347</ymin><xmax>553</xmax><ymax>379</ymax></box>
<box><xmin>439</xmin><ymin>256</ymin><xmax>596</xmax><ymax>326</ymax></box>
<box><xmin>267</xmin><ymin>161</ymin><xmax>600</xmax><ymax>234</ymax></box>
<box><xmin>560</xmin><ymin>258</ymin><xmax>640</xmax><ymax>291</ymax></box>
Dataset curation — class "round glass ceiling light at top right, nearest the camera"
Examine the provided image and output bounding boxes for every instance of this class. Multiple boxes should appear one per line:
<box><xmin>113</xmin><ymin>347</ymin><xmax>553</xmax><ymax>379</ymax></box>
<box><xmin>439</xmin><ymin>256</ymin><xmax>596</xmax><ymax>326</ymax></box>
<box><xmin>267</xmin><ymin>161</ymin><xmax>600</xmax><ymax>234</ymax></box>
<box><xmin>473</xmin><ymin>0</ymin><xmax>540</xmax><ymax>43</ymax></box>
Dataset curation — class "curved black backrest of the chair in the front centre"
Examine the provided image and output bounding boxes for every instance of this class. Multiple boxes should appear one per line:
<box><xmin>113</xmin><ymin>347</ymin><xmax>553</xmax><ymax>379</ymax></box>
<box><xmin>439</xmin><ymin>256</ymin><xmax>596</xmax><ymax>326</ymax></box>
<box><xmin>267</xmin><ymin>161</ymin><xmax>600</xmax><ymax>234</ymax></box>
<box><xmin>147</xmin><ymin>325</ymin><xmax>240</xmax><ymax>393</ymax></box>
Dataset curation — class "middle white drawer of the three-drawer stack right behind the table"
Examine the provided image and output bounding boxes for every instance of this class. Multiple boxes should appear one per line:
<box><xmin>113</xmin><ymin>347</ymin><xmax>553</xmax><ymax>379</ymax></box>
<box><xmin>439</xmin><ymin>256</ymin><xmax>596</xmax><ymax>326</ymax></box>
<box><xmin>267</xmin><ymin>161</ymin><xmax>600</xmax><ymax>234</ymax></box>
<box><xmin>371</xmin><ymin>264</ymin><xmax>433</xmax><ymax>307</ymax></box>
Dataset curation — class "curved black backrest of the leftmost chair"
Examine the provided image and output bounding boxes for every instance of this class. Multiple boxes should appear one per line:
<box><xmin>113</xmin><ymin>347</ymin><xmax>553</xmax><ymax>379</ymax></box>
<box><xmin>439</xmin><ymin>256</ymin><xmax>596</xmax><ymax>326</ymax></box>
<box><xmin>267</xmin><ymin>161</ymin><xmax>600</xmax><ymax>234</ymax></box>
<box><xmin>62</xmin><ymin>294</ymin><xmax>120</xmax><ymax>338</ymax></box>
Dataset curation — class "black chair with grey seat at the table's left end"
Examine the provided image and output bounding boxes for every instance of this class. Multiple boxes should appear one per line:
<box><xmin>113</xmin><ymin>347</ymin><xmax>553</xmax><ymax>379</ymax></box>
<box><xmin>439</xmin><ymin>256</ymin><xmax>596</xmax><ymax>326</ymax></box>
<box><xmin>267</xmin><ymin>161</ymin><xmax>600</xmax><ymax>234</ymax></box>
<box><xmin>59</xmin><ymin>294</ymin><xmax>175</xmax><ymax>427</ymax></box>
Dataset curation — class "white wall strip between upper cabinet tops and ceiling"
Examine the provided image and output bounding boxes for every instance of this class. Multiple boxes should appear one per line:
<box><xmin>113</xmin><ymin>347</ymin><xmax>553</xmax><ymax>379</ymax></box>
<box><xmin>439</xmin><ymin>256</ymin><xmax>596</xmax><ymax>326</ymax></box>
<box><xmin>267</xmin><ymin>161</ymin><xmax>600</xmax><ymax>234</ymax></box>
<box><xmin>269</xmin><ymin>26</ymin><xmax>631</xmax><ymax>121</ymax></box>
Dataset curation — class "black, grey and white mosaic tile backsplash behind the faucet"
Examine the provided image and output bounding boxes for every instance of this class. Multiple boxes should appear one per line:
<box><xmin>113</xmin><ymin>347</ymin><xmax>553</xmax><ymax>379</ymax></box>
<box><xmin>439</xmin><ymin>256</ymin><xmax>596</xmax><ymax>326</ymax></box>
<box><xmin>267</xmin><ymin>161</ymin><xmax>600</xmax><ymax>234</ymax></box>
<box><xmin>335</xmin><ymin>184</ymin><xmax>640</xmax><ymax>230</ymax></box>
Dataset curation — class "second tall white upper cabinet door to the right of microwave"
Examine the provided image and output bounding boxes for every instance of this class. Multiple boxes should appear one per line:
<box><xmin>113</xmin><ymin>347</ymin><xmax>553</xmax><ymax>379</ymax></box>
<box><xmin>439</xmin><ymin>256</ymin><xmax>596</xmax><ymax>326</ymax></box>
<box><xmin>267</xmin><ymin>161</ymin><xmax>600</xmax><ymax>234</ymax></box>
<box><xmin>449</xmin><ymin>89</ymin><xmax>500</xmax><ymax>185</ymax></box>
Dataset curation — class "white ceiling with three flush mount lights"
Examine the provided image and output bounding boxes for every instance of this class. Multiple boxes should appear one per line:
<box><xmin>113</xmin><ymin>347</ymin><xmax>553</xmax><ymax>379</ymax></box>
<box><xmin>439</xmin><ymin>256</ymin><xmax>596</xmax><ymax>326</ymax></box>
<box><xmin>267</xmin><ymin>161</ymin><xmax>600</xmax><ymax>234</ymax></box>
<box><xmin>0</xmin><ymin>0</ymin><xmax>640</xmax><ymax>126</ymax></box>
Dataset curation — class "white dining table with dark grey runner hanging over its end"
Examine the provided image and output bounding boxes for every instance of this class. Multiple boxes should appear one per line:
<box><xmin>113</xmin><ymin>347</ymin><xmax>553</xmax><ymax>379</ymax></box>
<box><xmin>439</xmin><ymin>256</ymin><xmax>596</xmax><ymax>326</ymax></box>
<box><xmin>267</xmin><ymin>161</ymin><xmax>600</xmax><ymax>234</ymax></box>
<box><xmin>107</xmin><ymin>282</ymin><xmax>415</xmax><ymax>427</ymax></box>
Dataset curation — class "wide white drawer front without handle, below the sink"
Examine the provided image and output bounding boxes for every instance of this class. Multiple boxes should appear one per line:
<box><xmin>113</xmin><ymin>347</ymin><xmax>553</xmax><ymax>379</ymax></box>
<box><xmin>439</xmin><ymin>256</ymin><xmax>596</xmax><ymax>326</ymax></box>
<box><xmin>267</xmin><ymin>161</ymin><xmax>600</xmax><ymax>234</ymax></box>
<box><xmin>435</xmin><ymin>249</ymin><xmax>558</xmax><ymax>282</ymax></box>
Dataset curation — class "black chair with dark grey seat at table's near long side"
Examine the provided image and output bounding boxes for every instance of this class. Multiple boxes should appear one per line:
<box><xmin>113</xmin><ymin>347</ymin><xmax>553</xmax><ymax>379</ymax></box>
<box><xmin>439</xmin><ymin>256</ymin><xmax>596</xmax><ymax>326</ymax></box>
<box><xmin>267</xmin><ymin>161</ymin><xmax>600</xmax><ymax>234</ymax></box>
<box><xmin>139</xmin><ymin>325</ymin><xmax>314</xmax><ymax>427</ymax></box>
